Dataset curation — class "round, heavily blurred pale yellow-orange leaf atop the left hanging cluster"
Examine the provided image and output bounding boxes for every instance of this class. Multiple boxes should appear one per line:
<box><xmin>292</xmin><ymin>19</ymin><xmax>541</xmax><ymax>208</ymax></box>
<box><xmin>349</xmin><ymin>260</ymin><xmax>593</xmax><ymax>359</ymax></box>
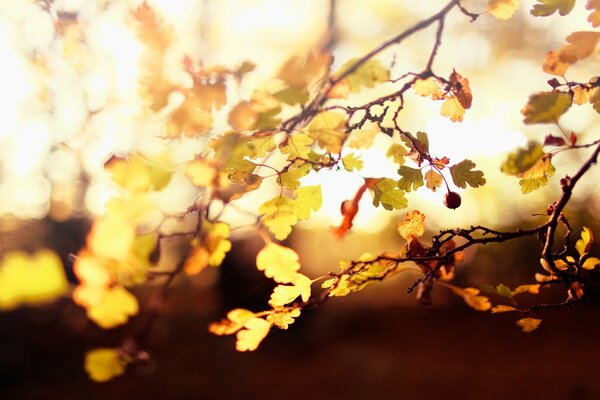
<box><xmin>87</xmin><ymin>212</ymin><xmax>135</xmax><ymax>260</ymax></box>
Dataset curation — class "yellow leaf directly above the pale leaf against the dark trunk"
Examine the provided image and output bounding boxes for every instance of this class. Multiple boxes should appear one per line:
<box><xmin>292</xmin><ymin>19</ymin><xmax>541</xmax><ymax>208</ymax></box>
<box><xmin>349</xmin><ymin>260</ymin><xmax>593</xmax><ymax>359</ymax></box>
<box><xmin>258</xmin><ymin>195</ymin><xmax>298</xmax><ymax>240</ymax></box>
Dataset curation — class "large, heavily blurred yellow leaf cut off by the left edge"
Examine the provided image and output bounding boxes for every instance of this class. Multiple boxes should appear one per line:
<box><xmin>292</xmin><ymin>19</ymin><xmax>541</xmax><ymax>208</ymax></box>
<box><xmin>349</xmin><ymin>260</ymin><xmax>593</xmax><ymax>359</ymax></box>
<box><xmin>0</xmin><ymin>250</ymin><xmax>68</xmax><ymax>310</ymax></box>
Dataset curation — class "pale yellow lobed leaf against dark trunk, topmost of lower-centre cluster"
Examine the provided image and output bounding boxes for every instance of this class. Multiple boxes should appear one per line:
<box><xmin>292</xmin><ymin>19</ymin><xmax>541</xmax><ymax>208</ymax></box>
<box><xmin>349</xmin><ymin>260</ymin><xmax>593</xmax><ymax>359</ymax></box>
<box><xmin>256</xmin><ymin>242</ymin><xmax>300</xmax><ymax>283</ymax></box>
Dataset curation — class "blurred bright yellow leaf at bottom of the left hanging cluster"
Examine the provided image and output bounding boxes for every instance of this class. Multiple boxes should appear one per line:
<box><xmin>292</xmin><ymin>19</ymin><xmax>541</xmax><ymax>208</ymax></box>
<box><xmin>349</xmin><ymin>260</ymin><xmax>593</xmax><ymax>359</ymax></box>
<box><xmin>87</xmin><ymin>286</ymin><xmax>139</xmax><ymax>329</ymax></box>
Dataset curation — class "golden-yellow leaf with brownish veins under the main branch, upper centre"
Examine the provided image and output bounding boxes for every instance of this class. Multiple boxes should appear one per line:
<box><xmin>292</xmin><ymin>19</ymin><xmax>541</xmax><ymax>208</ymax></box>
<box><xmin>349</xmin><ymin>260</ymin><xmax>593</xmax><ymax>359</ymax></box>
<box><xmin>306</xmin><ymin>111</ymin><xmax>346</xmax><ymax>153</ymax></box>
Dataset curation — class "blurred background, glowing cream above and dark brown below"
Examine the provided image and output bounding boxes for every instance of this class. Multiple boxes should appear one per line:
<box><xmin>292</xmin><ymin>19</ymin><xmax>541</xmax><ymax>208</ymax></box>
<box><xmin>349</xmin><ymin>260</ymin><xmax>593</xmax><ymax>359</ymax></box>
<box><xmin>0</xmin><ymin>0</ymin><xmax>600</xmax><ymax>399</ymax></box>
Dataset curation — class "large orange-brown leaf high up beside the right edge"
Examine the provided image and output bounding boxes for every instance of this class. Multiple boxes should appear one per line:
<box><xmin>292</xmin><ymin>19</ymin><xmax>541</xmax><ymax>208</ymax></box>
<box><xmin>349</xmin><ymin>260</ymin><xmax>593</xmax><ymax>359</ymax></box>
<box><xmin>543</xmin><ymin>32</ymin><xmax>600</xmax><ymax>76</ymax></box>
